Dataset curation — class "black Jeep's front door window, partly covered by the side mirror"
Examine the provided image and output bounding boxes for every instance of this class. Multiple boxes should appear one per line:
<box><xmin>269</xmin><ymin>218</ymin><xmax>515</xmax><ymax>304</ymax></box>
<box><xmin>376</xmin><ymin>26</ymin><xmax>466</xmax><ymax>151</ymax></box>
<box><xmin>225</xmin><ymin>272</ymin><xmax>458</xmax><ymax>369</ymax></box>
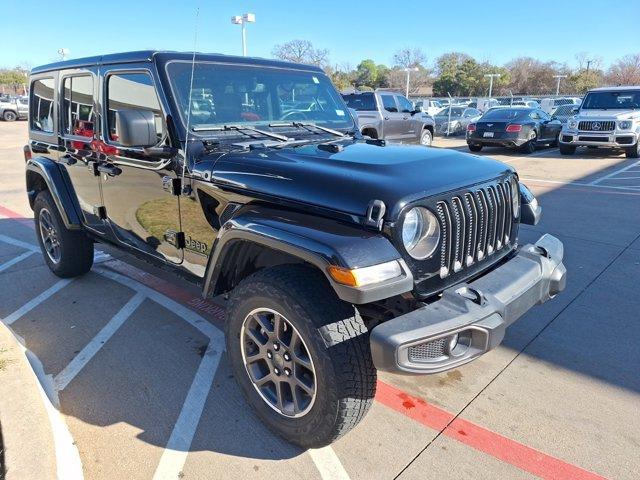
<box><xmin>106</xmin><ymin>73</ymin><xmax>164</xmax><ymax>143</ymax></box>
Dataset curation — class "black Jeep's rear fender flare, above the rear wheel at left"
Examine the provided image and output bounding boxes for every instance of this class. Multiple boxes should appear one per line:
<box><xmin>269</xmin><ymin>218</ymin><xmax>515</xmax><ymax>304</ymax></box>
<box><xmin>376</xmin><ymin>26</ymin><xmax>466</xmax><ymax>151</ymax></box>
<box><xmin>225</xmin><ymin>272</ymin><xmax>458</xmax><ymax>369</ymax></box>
<box><xmin>26</xmin><ymin>157</ymin><xmax>82</xmax><ymax>230</ymax></box>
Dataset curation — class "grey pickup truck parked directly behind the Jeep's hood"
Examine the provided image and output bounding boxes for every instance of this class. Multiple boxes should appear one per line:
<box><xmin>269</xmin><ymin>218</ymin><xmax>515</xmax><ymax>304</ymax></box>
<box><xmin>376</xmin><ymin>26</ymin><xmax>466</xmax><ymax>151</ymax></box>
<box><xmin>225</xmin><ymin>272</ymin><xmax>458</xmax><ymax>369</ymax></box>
<box><xmin>342</xmin><ymin>91</ymin><xmax>435</xmax><ymax>147</ymax></box>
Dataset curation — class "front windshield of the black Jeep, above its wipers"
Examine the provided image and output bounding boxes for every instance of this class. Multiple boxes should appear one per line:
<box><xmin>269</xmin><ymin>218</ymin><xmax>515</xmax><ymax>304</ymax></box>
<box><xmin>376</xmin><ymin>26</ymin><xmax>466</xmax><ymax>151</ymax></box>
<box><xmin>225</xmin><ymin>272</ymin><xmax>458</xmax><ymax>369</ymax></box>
<box><xmin>167</xmin><ymin>61</ymin><xmax>355</xmax><ymax>135</ymax></box>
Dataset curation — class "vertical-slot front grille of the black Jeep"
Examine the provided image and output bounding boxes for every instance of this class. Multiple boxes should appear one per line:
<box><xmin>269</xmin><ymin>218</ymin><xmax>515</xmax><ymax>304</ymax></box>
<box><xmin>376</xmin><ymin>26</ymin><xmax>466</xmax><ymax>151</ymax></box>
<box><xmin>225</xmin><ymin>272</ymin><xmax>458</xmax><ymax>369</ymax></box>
<box><xmin>436</xmin><ymin>180</ymin><xmax>513</xmax><ymax>278</ymax></box>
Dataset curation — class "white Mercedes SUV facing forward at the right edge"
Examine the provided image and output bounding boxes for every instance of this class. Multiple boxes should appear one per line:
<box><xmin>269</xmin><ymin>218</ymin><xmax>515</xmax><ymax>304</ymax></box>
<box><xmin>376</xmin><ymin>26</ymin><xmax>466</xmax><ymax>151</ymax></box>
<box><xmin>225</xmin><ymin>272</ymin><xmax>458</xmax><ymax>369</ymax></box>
<box><xmin>559</xmin><ymin>87</ymin><xmax>640</xmax><ymax>158</ymax></box>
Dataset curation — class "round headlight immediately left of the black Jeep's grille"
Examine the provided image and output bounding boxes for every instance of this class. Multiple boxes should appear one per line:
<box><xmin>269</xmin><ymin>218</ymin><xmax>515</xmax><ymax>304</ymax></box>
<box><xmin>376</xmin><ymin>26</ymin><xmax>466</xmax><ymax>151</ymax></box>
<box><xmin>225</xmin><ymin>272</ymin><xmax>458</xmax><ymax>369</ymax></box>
<box><xmin>402</xmin><ymin>207</ymin><xmax>440</xmax><ymax>260</ymax></box>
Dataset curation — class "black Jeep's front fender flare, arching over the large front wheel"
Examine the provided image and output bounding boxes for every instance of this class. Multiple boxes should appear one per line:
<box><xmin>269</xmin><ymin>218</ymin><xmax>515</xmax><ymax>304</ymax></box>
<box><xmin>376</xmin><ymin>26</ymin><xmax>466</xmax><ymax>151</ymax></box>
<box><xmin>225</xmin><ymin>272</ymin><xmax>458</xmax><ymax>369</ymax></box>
<box><xmin>203</xmin><ymin>207</ymin><xmax>413</xmax><ymax>304</ymax></box>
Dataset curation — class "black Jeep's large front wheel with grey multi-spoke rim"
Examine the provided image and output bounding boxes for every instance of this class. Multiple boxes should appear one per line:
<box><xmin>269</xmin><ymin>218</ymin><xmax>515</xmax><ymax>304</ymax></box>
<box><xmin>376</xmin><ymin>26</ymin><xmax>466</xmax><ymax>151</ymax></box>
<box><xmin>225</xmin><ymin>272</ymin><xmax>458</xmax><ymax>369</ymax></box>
<box><xmin>225</xmin><ymin>265</ymin><xmax>376</xmax><ymax>448</ymax></box>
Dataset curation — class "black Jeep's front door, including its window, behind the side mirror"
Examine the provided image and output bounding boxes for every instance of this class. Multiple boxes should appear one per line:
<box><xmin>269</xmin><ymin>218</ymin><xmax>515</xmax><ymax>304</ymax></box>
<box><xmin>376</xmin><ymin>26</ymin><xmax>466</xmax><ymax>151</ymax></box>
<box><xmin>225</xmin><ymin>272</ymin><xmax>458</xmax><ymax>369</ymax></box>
<box><xmin>99</xmin><ymin>70</ymin><xmax>183</xmax><ymax>263</ymax></box>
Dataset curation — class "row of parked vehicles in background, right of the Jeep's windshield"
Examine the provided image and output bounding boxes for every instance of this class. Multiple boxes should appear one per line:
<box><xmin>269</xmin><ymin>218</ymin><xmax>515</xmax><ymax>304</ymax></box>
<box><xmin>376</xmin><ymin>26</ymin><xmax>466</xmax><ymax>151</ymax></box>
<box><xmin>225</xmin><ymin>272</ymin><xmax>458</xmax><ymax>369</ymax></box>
<box><xmin>343</xmin><ymin>87</ymin><xmax>640</xmax><ymax>158</ymax></box>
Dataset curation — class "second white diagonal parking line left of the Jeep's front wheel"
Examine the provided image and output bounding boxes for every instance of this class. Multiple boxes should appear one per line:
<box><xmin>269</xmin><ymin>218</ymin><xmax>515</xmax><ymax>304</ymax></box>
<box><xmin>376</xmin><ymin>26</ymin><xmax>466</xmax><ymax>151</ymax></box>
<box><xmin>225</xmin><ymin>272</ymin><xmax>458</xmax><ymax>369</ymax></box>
<box><xmin>53</xmin><ymin>292</ymin><xmax>145</xmax><ymax>391</ymax></box>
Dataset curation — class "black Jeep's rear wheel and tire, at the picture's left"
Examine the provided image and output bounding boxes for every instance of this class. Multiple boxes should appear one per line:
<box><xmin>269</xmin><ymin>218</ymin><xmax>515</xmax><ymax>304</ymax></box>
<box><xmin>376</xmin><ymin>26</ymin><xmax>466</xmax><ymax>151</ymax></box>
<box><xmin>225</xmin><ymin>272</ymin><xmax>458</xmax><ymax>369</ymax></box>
<box><xmin>33</xmin><ymin>190</ymin><xmax>93</xmax><ymax>278</ymax></box>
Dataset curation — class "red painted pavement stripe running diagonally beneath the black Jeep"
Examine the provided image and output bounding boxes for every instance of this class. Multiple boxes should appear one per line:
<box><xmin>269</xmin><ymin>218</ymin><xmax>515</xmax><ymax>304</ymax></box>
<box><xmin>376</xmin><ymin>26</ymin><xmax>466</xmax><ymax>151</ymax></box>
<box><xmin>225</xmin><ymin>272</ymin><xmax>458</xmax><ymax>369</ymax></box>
<box><xmin>0</xmin><ymin>206</ymin><xmax>605</xmax><ymax>480</ymax></box>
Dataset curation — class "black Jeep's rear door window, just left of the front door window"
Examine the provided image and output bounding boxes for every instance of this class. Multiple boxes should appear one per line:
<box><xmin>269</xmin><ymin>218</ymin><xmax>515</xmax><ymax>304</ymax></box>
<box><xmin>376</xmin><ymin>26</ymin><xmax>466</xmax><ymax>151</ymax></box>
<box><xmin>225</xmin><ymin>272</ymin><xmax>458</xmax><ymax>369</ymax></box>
<box><xmin>62</xmin><ymin>75</ymin><xmax>95</xmax><ymax>137</ymax></box>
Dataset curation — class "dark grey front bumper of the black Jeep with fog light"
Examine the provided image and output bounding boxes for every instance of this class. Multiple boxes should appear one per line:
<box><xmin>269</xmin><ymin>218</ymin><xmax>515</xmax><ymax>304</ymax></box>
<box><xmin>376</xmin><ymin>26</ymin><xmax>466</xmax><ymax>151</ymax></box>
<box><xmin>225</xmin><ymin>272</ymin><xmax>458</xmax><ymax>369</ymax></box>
<box><xmin>370</xmin><ymin>235</ymin><xmax>567</xmax><ymax>374</ymax></box>
